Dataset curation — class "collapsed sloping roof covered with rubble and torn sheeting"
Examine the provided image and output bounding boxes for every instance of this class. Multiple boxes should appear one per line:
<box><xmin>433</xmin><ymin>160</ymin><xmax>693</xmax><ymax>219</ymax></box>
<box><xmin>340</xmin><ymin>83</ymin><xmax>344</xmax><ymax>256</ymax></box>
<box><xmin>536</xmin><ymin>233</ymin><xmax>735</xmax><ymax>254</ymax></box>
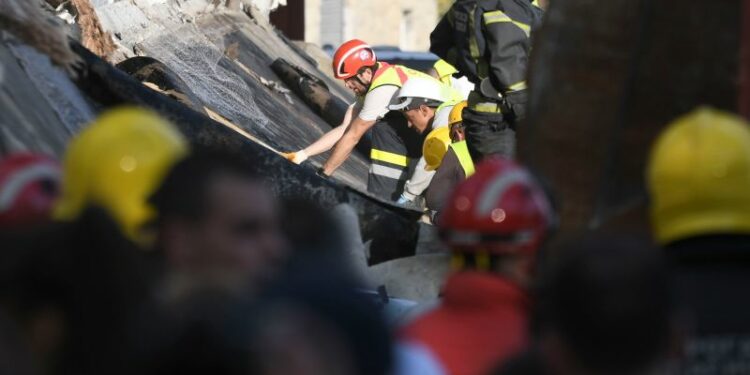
<box><xmin>0</xmin><ymin>0</ymin><xmax>419</xmax><ymax>263</ymax></box>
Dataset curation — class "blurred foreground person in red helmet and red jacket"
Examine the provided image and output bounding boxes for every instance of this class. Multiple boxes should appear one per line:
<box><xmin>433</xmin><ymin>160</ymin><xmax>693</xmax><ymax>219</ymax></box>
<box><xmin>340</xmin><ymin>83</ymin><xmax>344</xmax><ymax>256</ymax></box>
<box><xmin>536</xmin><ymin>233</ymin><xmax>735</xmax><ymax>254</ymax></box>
<box><xmin>402</xmin><ymin>159</ymin><xmax>554</xmax><ymax>375</ymax></box>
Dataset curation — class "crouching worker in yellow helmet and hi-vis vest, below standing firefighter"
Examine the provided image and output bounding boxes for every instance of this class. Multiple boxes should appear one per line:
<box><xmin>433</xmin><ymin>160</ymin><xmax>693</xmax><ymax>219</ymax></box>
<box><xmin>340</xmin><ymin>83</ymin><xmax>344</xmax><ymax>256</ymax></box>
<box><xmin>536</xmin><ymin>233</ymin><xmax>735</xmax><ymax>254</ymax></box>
<box><xmin>426</xmin><ymin>101</ymin><xmax>474</xmax><ymax>222</ymax></box>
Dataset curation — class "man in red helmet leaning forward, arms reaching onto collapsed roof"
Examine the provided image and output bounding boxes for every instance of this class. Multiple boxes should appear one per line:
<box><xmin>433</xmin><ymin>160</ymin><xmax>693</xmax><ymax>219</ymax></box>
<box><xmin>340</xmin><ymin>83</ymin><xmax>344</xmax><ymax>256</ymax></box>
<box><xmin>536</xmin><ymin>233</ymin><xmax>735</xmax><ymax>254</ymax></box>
<box><xmin>287</xmin><ymin>39</ymin><xmax>440</xmax><ymax>201</ymax></box>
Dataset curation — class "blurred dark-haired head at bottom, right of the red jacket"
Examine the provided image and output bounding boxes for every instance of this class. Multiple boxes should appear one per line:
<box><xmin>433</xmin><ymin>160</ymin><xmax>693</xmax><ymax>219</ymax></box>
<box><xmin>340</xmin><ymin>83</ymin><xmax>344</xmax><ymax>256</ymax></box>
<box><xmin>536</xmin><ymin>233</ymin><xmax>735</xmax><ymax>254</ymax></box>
<box><xmin>528</xmin><ymin>233</ymin><xmax>681</xmax><ymax>375</ymax></box>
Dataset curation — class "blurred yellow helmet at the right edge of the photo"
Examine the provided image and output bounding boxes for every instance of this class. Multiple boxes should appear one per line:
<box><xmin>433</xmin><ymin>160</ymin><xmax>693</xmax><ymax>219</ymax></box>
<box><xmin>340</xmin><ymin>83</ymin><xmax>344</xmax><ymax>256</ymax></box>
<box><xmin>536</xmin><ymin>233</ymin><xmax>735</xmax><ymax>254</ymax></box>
<box><xmin>647</xmin><ymin>108</ymin><xmax>750</xmax><ymax>243</ymax></box>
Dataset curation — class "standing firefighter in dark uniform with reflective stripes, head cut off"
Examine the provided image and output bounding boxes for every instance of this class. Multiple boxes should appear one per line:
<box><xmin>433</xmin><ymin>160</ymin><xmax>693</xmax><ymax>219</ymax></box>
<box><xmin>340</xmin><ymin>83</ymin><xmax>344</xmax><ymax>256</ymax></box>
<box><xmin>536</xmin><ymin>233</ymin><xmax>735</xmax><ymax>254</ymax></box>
<box><xmin>430</xmin><ymin>0</ymin><xmax>542</xmax><ymax>160</ymax></box>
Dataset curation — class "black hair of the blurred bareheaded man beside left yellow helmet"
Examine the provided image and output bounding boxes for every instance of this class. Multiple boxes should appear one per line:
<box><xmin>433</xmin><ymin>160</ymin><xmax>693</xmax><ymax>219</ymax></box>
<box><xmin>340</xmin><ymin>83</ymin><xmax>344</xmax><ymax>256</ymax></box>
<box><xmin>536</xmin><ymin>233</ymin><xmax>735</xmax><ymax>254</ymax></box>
<box><xmin>149</xmin><ymin>148</ymin><xmax>260</xmax><ymax>220</ymax></box>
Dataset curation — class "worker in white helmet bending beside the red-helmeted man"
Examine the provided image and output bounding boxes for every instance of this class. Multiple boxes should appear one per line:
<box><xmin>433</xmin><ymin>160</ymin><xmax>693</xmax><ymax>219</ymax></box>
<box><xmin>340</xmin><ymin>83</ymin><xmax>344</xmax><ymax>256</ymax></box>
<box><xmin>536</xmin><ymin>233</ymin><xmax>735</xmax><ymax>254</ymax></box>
<box><xmin>388</xmin><ymin>77</ymin><xmax>458</xmax><ymax>204</ymax></box>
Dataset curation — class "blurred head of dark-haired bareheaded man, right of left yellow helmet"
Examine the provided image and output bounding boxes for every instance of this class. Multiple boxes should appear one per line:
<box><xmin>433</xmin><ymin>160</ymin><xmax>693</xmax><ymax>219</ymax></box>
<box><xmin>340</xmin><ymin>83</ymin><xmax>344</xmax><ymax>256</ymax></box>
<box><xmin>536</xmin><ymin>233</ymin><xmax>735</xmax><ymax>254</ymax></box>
<box><xmin>150</xmin><ymin>149</ymin><xmax>288</xmax><ymax>299</ymax></box>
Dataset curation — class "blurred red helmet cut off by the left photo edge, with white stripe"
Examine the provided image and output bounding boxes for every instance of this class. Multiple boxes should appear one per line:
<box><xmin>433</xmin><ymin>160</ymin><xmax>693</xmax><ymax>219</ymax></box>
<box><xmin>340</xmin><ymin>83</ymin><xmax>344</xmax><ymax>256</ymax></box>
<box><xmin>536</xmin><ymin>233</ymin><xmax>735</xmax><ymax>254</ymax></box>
<box><xmin>0</xmin><ymin>153</ymin><xmax>61</xmax><ymax>227</ymax></box>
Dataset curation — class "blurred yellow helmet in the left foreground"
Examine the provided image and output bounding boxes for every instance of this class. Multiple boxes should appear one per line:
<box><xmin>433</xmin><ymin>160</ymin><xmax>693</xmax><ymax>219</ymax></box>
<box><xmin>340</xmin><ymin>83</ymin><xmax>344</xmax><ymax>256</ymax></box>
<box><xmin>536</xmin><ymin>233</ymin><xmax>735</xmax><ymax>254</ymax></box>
<box><xmin>54</xmin><ymin>107</ymin><xmax>188</xmax><ymax>245</ymax></box>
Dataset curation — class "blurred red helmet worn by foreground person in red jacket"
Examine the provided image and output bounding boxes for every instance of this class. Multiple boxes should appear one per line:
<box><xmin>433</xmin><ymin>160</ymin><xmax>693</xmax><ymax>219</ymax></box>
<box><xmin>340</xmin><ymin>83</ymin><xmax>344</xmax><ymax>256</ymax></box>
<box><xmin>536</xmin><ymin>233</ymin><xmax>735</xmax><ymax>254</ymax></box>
<box><xmin>438</xmin><ymin>159</ymin><xmax>554</xmax><ymax>255</ymax></box>
